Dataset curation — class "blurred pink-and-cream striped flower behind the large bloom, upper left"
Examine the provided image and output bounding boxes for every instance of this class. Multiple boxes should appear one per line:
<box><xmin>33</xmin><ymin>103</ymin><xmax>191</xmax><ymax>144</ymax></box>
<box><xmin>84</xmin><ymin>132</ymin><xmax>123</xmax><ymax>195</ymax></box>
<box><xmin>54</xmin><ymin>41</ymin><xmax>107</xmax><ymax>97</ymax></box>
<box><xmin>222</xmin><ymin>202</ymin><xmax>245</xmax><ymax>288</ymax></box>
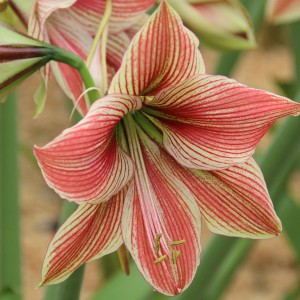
<box><xmin>29</xmin><ymin>0</ymin><xmax>155</xmax><ymax>113</ymax></box>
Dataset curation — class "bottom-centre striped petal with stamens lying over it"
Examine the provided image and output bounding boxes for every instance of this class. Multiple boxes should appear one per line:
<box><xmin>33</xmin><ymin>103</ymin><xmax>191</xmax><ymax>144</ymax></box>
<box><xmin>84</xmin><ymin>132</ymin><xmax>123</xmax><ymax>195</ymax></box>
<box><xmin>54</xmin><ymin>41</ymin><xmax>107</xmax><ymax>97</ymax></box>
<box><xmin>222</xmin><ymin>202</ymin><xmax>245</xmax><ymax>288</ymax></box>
<box><xmin>122</xmin><ymin>131</ymin><xmax>201</xmax><ymax>295</ymax></box>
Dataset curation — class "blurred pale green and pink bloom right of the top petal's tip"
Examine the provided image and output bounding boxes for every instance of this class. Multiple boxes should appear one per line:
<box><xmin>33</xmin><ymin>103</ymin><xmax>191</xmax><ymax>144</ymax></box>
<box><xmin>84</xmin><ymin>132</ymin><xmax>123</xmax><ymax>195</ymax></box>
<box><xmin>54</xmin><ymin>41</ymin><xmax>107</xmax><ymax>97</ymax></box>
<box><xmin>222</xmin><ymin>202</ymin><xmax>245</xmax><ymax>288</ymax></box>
<box><xmin>170</xmin><ymin>0</ymin><xmax>256</xmax><ymax>50</ymax></box>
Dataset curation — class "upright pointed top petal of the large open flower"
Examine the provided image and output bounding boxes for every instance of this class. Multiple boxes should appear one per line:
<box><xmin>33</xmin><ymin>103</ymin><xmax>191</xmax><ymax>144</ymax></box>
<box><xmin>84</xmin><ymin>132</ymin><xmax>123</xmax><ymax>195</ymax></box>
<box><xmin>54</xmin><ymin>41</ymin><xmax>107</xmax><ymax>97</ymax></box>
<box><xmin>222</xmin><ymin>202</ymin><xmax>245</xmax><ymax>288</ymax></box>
<box><xmin>109</xmin><ymin>1</ymin><xmax>204</xmax><ymax>95</ymax></box>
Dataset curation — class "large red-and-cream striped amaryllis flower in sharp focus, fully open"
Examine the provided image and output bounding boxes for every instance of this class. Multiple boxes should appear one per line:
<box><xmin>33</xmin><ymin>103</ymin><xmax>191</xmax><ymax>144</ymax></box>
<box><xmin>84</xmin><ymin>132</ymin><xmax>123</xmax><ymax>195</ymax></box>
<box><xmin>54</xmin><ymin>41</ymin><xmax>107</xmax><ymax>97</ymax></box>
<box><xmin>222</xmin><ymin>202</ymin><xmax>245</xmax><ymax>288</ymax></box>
<box><xmin>35</xmin><ymin>1</ymin><xmax>300</xmax><ymax>295</ymax></box>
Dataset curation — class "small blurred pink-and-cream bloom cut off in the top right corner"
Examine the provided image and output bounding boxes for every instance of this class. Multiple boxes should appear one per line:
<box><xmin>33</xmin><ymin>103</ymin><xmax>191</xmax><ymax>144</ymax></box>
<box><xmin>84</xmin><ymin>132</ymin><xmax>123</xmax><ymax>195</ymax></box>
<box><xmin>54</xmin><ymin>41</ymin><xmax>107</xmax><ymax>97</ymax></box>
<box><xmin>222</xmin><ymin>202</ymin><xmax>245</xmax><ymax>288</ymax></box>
<box><xmin>266</xmin><ymin>0</ymin><xmax>300</xmax><ymax>24</ymax></box>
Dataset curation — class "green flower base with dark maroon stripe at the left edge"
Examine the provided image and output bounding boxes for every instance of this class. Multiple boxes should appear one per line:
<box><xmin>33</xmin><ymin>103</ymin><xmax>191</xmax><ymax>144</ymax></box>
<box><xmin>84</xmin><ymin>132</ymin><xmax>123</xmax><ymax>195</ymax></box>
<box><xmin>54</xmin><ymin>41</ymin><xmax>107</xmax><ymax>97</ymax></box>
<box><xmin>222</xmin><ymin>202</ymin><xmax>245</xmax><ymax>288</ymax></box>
<box><xmin>0</xmin><ymin>23</ymin><xmax>51</xmax><ymax>102</ymax></box>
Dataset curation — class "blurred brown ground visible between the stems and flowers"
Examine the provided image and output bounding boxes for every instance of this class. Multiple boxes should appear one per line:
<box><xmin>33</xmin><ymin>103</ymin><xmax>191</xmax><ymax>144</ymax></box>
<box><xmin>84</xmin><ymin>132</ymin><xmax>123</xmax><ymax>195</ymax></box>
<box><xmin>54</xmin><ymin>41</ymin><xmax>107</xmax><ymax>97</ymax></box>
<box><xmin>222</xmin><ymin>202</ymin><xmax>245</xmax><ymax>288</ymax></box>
<box><xmin>19</xmin><ymin>42</ymin><xmax>299</xmax><ymax>300</ymax></box>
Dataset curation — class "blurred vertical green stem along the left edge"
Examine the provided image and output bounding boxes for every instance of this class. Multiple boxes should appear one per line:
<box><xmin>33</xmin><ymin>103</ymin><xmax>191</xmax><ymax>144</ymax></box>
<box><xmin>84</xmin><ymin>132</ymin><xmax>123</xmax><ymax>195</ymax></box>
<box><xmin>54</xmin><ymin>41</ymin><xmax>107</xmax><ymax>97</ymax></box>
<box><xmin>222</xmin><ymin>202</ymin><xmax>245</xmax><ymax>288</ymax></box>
<box><xmin>0</xmin><ymin>94</ymin><xmax>21</xmax><ymax>300</ymax></box>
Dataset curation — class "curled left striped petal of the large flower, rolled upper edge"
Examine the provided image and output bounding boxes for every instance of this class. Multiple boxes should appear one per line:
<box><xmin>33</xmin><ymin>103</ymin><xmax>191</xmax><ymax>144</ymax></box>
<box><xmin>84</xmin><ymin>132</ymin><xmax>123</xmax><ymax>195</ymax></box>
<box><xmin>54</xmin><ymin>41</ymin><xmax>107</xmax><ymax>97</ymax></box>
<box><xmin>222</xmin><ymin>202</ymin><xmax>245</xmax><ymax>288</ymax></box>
<box><xmin>35</xmin><ymin>95</ymin><xmax>141</xmax><ymax>204</ymax></box>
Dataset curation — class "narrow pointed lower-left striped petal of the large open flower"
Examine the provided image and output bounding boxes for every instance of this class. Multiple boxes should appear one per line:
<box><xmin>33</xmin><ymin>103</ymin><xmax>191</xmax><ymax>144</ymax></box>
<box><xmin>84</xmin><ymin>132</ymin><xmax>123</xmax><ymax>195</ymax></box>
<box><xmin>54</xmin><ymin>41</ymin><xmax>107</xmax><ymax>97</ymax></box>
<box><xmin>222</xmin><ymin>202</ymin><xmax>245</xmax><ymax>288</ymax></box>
<box><xmin>40</xmin><ymin>189</ymin><xmax>126</xmax><ymax>285</ymax></box>
